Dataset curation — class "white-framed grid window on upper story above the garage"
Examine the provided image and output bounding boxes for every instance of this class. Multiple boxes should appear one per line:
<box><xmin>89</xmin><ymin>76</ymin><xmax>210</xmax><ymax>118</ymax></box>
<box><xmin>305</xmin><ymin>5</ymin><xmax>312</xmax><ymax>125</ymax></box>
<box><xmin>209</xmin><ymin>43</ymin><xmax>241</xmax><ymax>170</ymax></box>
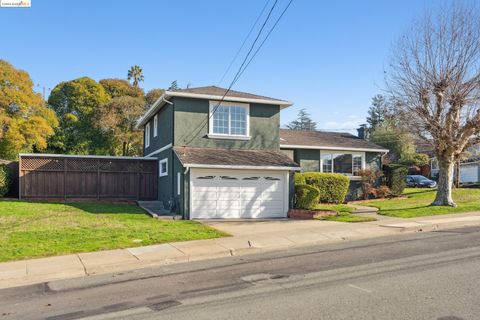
<box><xmin>209</xmin><ymin>101</ymin><xmax>250</xmax><ymax>138</ymax></box>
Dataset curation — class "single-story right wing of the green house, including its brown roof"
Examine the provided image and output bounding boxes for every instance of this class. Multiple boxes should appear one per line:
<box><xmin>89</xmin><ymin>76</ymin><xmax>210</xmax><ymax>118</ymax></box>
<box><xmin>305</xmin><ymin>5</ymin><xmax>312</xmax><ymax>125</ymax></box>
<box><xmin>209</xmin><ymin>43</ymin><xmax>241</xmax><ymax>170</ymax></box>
<box><xmin>280</xmin><ymin>129</ymin><xmax>388</xmax><ymax>199</ymax></box>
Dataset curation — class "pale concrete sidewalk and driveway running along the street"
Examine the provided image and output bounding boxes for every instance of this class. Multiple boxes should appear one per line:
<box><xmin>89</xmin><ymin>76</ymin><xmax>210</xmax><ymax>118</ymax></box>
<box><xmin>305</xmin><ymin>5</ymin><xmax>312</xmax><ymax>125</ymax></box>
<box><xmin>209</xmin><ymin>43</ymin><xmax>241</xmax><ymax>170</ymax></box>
<box><xmin>0</xmin><ymin>211</ymin><xmax>480</xmax><ymax>288</ymax></box>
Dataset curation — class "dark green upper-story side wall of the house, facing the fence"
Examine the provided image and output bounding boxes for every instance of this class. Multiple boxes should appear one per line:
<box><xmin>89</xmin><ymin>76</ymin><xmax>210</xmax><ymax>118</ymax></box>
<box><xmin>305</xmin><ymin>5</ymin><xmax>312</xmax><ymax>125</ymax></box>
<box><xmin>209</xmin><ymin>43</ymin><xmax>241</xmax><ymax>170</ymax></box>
<box><xmin>143</xmin><ymin>104</ymin><xmax>173</xmax><ymax>155</ymax></box>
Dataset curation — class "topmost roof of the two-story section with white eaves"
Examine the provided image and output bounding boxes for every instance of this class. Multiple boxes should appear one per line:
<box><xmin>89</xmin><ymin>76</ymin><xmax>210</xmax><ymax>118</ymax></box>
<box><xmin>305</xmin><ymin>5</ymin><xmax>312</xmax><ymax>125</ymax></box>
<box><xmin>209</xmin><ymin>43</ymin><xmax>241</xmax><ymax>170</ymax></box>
<box><xmin>137</xmin><ymin>86</ymin><xmax>293</xmax><ymax>128</ymax></box>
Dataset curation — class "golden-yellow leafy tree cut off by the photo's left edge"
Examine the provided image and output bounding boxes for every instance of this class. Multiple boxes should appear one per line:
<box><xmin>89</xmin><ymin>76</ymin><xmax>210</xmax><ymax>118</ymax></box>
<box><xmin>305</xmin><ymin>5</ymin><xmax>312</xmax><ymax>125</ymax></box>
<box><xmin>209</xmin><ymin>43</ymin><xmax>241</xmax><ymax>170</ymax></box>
<box><xmin>0</xmin><ymin>60</ymin><xmax>58</xmax><ymax>159</ymax></box>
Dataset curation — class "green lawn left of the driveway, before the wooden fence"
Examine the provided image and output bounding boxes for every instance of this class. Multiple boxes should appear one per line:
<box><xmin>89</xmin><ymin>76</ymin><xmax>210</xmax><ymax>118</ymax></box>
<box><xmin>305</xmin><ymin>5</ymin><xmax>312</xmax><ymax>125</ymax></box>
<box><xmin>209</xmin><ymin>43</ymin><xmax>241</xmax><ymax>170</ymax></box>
<box><xmin>0</xmin><ymin>201</ymin><xmax>226</xmax><ymax>262</ymax></box>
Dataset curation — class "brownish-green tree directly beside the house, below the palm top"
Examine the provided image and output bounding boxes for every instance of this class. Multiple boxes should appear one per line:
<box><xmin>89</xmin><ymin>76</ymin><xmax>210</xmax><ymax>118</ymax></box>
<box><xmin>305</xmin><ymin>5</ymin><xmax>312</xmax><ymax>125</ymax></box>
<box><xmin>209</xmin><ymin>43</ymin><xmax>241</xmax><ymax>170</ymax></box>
<box><xmin>96</xmin><ymin>96</ymin><xmax>145</xmax><ymax>156</ymax></box>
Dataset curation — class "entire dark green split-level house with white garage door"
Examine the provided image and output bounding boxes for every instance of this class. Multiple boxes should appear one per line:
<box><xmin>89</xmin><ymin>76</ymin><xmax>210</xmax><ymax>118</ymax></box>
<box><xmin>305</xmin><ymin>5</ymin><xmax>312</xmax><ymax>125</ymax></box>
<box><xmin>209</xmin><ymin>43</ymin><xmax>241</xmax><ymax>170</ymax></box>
<box><xmin>138</xmin><ymin>86</ymin><xmax>386</xmax><ymax>219</ymax></box>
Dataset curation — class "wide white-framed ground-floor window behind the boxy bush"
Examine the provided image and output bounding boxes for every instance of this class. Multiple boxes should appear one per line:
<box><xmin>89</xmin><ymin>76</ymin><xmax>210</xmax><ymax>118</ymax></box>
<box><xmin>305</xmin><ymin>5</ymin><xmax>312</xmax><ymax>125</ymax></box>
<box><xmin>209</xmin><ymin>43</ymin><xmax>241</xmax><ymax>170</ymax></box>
<box><xmin>321</xmin><ymin>152</ymin><xmax>365</xmax><ymax>176</ymax></box>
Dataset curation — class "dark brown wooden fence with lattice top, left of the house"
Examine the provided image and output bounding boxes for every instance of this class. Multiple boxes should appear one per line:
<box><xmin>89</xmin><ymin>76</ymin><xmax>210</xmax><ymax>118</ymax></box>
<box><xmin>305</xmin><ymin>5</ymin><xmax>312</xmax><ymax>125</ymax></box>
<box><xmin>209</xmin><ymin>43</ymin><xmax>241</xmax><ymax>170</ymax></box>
<box><xmin>19</xmin><ymin>154</ymin><xmax>158</xmax><ymax>200</ymax></box>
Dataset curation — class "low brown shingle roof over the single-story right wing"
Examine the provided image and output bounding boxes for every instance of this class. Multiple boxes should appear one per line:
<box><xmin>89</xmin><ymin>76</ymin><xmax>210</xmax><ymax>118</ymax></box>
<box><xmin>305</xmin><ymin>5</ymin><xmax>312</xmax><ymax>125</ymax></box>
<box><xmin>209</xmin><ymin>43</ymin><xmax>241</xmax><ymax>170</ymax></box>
<box><xmin>280</xmin><ymin>129</ymin><xmax>385</xmax><ymax>150</ymax></box>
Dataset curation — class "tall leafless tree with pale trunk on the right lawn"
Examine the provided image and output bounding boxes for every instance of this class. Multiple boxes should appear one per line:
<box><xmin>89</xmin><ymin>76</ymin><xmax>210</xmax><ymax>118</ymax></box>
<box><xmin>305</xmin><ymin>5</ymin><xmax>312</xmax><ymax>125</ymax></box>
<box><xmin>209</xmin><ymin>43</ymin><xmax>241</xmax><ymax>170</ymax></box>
<box><xmin>386</xmin><ymin>3</ymin><xmax>480</xmax><ymax>206</ymax></box>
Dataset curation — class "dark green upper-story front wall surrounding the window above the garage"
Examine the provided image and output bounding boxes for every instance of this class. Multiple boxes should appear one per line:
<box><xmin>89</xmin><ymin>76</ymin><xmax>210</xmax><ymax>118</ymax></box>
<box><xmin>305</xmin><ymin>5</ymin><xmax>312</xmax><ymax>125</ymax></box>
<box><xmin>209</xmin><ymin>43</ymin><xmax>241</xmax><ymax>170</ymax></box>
<box><xmin>172</xmin><ymin>97</ymin><xmax>280</xmax><ymax>150</ymax></box>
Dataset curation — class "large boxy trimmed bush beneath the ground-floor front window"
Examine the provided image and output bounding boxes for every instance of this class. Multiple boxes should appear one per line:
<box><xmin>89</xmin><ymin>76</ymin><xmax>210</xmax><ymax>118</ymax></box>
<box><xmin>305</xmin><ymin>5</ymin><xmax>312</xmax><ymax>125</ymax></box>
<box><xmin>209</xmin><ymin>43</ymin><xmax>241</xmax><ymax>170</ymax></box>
<box><xmin>303</xmin><ymin>172</ymin><xmax>350</xmax><ymax>203</ymax></box>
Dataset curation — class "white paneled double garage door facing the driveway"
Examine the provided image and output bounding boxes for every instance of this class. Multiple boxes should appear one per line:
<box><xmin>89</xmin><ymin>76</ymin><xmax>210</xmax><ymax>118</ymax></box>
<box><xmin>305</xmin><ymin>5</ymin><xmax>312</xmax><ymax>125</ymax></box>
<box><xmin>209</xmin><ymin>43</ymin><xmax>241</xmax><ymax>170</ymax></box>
<box><xmin>190</xmin><ymin>169</ymin><xmax>288</xmax><ymax>219</ymax></box>
